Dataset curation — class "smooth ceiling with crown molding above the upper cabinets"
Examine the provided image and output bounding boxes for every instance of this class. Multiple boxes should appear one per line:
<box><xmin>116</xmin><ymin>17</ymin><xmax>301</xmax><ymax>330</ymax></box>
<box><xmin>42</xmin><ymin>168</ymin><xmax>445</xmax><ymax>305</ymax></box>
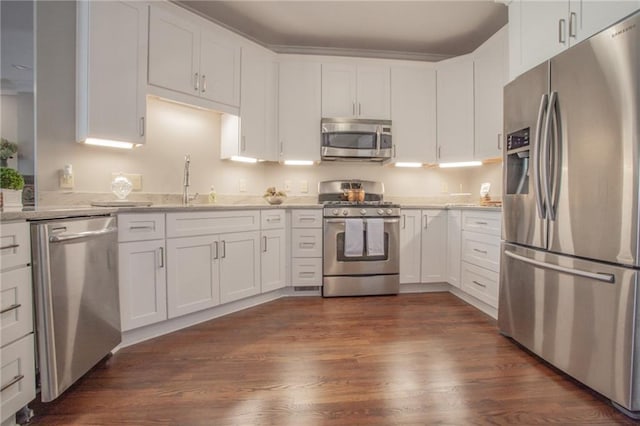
<box><xmin>175</xmin><ymin>0</ymin><xmax>507</xmax><ymax>61</ymax></box>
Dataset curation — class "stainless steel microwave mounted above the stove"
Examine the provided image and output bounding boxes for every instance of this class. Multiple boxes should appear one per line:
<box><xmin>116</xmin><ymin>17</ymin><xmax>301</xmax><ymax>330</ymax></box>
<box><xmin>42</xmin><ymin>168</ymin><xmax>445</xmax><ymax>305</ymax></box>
<box><xmin>320</xmin><ymin>118</ymin><xmax>393</xmax><ymax>162</ymax></box>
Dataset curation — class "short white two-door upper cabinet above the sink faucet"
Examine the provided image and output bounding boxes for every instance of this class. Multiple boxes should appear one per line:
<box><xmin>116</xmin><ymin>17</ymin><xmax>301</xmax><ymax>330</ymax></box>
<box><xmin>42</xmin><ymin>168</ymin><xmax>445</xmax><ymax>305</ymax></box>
<box><xmin>149</xmin><ymin>5</ymin><xmax>241</xmax><ymax>107</ymax></box>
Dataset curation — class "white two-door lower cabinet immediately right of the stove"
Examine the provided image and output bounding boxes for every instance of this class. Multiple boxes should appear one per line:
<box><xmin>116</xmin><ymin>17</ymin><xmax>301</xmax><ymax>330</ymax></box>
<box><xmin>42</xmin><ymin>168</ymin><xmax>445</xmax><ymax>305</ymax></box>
<box><xmin>400</xmin><ymin>209</ymin><xmax>447</xmax><ymax>284</ymax></box>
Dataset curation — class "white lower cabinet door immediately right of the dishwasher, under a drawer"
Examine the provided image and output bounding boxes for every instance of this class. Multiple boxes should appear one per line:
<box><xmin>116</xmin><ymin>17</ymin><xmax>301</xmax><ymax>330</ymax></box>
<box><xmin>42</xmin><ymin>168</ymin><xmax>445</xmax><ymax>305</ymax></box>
<box><xmin>118</xmin><ymin>240</ymin><xmax>167</xmax><ymax>331</ymax></box>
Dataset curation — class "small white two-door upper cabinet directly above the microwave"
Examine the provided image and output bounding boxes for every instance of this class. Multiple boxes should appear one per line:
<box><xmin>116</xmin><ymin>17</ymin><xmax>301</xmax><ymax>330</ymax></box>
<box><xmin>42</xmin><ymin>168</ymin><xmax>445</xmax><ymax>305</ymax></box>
<box><xmin>322</xmin><ymin>64</ymin><xmax>391</xmax><ymax>119</ymax></box>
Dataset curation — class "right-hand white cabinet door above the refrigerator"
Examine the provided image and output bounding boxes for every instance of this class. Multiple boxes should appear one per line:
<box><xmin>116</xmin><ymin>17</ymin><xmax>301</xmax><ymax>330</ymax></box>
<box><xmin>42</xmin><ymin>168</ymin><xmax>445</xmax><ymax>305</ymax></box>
<box><xmin>569</xmin><ymin>0</ymin><xmax>640</xmax><ymax>45</ymax></box>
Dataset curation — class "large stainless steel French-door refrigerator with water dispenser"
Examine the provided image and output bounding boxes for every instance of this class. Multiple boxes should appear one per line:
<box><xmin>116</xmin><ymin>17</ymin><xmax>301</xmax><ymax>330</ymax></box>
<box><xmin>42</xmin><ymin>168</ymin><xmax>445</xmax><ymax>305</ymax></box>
<box><xmin>498</xmin><ymin>13</ymin><xmax>640</xmax><ymax>416</ymax></box>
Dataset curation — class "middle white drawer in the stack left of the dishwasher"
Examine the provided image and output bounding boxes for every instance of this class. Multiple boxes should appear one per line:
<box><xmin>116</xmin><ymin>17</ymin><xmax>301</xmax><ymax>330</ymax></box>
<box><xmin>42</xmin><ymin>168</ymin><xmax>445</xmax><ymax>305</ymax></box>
<box><xmin>0</xmin><ymin>267</ymin><xmax>33</xmax><ymax>346</ymax></box>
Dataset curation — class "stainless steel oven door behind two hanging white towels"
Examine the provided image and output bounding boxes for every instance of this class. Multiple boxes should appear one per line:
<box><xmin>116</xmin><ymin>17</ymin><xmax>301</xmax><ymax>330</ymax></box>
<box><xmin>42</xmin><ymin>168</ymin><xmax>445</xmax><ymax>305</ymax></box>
<box><xmin>323</xmin><ymin>218</ymin><xmax>400</xmax><ymax>276</ymax></box>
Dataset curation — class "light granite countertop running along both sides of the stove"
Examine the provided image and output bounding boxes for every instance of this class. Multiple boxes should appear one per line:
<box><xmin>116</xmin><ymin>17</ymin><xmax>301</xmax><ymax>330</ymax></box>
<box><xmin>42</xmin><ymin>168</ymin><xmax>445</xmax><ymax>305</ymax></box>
<box><xmin>0</xmin><ymin>203</ymin><xmax>502</xmax><ymax>222</ymax></box>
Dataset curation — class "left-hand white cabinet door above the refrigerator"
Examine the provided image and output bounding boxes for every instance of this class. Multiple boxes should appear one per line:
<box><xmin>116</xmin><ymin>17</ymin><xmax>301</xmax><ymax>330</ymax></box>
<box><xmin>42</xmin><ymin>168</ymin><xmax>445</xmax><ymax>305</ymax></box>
<box><xmin>520</xmin><ymin>1</ymin><xmax>569</xmax><ymax>71</ymax></box>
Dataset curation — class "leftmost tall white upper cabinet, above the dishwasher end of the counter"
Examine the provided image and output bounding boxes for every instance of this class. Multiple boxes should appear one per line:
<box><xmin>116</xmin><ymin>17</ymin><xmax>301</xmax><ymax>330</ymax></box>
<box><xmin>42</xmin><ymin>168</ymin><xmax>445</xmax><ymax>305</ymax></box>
<box><xmin>76</xmin><ymin>1</ymin><xmax>147</xmax><ymax>144</ymax></box>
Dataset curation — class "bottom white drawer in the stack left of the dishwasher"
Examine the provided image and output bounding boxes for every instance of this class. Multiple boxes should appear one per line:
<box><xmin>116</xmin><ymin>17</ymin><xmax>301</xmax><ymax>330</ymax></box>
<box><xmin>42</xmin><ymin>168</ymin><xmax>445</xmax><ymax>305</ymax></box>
<box><xmin>0</xmin><ymin>333</ymin><xmax>36</xmax><ymax>422</ymax></box>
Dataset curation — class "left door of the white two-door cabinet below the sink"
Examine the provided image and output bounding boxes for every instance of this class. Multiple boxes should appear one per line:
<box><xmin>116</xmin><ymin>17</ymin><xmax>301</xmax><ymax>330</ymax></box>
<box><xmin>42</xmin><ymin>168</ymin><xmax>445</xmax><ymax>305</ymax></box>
<box><xmin>167</xmin><ymin>235</ymin><xmax>221</xmax><ymax>318</ymax></box>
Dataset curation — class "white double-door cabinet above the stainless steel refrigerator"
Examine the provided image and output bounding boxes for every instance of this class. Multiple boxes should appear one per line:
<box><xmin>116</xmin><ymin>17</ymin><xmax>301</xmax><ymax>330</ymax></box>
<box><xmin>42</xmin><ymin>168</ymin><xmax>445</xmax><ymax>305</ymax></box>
<box><xmin>509</xmin><ymin>0</ymin><xmax>640</xmax><ymax>79</ymax></box>
